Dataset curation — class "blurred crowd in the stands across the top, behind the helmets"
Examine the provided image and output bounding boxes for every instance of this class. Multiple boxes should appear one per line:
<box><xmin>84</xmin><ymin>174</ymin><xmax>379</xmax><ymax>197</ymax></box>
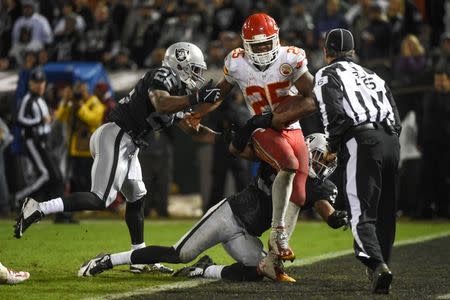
<box><xmin>0</xmin><ymin>0</ymin><xmax>450</xmax><ymax>73</ymax></box>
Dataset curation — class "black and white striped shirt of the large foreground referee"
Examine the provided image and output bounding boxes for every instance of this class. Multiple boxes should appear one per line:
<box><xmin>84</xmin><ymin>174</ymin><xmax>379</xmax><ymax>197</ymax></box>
<box><xmin>314</xmin><ymin>58</ymin><xmax>400</xmax><ymax>150</ymax></box>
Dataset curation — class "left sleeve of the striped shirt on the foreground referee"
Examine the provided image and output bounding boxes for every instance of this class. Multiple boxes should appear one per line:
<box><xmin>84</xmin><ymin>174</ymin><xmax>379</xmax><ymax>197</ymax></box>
<box><xmin>314</xmin><ymin>70</ymin><xmax>353</xmax><ymax>152</ymax></box>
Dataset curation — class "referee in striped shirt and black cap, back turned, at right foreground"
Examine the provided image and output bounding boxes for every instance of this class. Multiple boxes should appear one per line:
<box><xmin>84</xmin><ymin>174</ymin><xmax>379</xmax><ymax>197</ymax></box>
<box><xmin>314</xmin><ymin>28</ymin><xmax>401</xmax><ymax>294</ymax></box>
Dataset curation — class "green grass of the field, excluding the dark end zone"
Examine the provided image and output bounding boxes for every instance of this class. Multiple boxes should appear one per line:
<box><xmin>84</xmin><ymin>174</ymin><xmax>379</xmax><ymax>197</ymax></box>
<box><xmin>0</xmin><ymin>220</ymin><xmax>450</xmax><ymax>299</ymax></box>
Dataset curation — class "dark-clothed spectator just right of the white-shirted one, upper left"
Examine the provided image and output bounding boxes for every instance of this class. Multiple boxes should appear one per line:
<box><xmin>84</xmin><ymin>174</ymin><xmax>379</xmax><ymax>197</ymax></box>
<box><xmin>54</xmin><ymin>15</ymin><xmax>82</xmax><ymax>61</ymax></box>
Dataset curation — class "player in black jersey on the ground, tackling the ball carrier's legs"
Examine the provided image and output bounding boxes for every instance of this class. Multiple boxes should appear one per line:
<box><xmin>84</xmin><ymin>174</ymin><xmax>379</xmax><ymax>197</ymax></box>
<box><xmin>78</xmin><ymin>131</ymin><xmax>347</xmax><ymax>282</ymax></box>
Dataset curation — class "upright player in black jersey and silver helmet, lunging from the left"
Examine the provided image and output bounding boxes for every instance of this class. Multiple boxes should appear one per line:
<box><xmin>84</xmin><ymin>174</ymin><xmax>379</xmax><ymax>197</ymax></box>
<box><xmin>14</xmin><ymin>42</ymin><xmax>219</xmax><ymax>272</ymax></box>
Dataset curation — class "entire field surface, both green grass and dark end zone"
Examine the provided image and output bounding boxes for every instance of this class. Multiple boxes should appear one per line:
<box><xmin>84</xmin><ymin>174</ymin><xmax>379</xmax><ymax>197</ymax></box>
<box><xmin>0</xmin><ymin>220</ymin><xmax>450</xmax><ymax>299</ymax></box>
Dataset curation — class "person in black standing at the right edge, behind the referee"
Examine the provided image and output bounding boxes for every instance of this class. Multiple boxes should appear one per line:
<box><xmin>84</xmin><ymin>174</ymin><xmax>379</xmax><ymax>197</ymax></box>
<box><xmin>418</xmin><ymin>65</ymin><xmax>450</xmax><ymax>218</ymax></box>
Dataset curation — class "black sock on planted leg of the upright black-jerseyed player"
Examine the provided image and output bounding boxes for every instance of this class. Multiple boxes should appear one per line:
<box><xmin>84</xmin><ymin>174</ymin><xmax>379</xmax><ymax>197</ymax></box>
<box><xmin>125</xmin><ymin>199</ymin><xmax>144</xmax><ymax>245</ymax></box>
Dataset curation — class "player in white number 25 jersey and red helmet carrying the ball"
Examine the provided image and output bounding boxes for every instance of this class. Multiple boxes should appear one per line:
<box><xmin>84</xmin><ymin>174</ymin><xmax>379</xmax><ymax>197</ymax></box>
<box><xmin>193</xmin><ymin>13</ymin><xmax>316</xmax><ymax>260</ymax></box>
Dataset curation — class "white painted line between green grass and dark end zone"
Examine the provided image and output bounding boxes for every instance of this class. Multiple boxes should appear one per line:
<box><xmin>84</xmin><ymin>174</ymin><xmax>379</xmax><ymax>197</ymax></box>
<box><xmin>85</xmin><ymin>231</ymin><xmax>450</xmax><ymax>300</ymax></box>
